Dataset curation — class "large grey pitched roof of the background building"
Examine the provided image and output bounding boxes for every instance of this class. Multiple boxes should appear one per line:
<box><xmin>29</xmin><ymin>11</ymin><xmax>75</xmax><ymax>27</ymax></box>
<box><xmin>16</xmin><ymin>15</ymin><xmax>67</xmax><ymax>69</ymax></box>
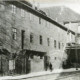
<box><xmin>42</xmin><ymin>6</ymin><xmax>80</xmax><ymax>22</ymax></box>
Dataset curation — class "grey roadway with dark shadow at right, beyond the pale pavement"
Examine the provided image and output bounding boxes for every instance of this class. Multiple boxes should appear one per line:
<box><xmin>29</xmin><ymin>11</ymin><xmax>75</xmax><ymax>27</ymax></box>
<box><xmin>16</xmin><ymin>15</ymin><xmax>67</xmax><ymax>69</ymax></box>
<box><xmin>20</xmin><ymin>72</ymin><xmax>80</xmax><ymax>80</ymax></box>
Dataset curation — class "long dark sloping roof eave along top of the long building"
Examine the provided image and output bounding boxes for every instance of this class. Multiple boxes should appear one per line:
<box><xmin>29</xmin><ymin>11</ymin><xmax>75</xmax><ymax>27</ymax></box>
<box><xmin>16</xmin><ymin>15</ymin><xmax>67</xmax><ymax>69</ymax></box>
<box><xmin>7</xmin><ymin>1</ymin><xmax>75</xmax><ymax>34</ymax></box>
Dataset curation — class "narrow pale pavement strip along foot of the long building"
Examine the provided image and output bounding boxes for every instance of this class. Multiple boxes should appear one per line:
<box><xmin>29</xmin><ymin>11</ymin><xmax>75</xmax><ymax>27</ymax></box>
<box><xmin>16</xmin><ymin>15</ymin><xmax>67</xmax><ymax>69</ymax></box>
<box><xmin>0</xmin><ymin>68</ymin><xmax>80</xmax><ymax>80</ymax></box>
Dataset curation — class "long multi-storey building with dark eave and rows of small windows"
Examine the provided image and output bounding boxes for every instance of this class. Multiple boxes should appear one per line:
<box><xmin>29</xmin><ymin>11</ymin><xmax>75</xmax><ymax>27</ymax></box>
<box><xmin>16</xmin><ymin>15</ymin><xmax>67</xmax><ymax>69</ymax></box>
<box><xmin>0</xmin><ymin>1</ymin><xmax>75</xmax><ymax>74</ymax></box>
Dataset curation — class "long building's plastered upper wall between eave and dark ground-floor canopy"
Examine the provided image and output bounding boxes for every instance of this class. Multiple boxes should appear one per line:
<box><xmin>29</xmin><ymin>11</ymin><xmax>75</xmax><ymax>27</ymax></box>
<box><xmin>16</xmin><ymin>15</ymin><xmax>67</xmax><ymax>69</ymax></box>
<box><xmin>0</xmin><ymin>3</ymin><xmax>75</xmax><ymax>70</ymax></box>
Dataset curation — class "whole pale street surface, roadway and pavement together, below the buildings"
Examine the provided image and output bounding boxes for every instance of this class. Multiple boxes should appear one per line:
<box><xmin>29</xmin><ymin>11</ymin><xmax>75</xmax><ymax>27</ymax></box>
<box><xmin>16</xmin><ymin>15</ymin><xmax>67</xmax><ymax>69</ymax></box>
<box><xmin>0</xmin><ymin>68</ymin><xmax>80</xmax><ymax>80</ymax></box>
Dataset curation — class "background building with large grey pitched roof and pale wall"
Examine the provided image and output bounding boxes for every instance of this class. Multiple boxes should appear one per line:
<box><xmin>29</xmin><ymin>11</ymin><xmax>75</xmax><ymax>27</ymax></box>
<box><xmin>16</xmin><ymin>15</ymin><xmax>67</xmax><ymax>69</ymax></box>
<box><xmin>42</xmin><ymin>6</ymin><xmax>80</xmax><ymax>42</ymax></box>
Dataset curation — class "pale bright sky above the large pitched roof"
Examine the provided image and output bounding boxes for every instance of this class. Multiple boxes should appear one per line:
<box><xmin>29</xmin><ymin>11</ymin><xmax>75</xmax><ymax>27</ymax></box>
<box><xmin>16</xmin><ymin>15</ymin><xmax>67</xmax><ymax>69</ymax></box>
<box><xmin>30</xmin><ymin>0</ymin><xmax>80</xmax><ymax>14</ymax></box>
